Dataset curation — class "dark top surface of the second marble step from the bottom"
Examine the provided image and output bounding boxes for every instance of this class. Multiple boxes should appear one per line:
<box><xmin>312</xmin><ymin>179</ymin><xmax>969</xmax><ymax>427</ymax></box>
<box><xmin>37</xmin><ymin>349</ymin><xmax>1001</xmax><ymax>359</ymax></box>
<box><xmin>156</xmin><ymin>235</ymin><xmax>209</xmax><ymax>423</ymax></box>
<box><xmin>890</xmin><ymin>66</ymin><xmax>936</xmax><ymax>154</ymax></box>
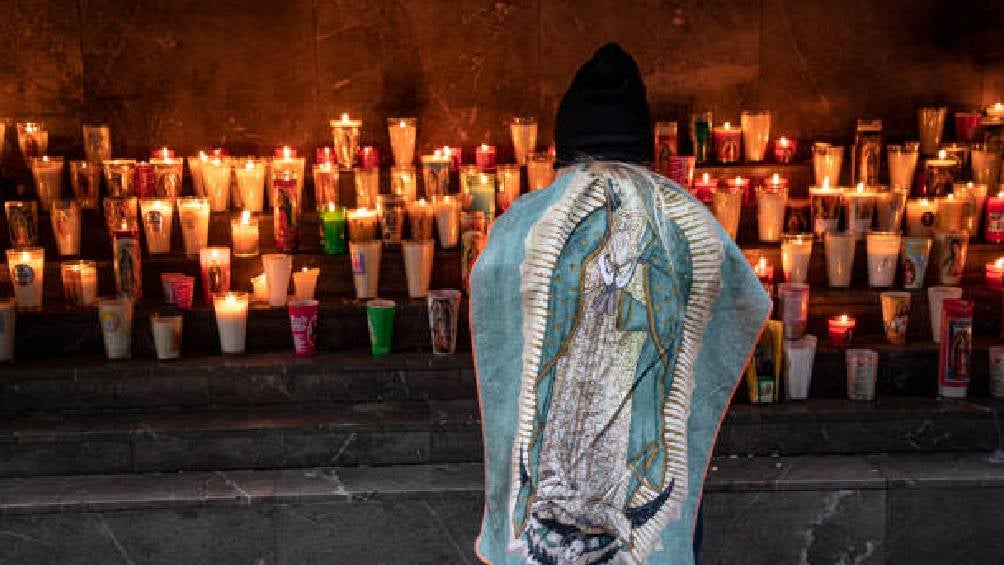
<box><xmin>0</xmin><ymin>396</ymin><xmax>1004</xmax><ymax>447</ymax></box>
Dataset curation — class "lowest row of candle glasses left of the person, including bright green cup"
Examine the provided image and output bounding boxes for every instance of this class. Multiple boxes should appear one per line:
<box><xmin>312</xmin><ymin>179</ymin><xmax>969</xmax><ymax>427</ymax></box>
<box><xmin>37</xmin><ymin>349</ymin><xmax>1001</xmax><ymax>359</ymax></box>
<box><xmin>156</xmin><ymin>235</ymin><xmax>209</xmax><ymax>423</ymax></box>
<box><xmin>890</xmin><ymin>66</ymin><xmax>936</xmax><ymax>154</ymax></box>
<box><xmin>0</xmin><ymin>289</ymin><xmax>461</xmax><ymax>362</ymax></box>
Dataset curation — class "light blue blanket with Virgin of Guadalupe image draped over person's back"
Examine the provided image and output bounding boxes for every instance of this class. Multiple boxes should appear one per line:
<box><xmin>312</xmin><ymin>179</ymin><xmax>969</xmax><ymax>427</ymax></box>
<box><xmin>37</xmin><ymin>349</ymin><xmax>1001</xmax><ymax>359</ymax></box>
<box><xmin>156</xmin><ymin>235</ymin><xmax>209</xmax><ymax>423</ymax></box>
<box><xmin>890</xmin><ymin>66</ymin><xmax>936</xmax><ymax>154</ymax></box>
<box><xmin>471</xmin><ymin>162</ymin><xmax>770</xmax><ymax>565</ymax></box>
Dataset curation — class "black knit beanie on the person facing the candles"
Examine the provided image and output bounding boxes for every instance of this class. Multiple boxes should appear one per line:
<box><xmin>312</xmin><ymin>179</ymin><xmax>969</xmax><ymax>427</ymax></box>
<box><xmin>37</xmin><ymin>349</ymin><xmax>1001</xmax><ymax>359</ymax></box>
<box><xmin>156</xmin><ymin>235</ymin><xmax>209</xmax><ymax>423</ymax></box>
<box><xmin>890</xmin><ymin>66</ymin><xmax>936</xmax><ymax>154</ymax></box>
<box><xmin>554</xmin><ymin>43</ymin><xmax>653</xmax><ymax>168</ymax></box>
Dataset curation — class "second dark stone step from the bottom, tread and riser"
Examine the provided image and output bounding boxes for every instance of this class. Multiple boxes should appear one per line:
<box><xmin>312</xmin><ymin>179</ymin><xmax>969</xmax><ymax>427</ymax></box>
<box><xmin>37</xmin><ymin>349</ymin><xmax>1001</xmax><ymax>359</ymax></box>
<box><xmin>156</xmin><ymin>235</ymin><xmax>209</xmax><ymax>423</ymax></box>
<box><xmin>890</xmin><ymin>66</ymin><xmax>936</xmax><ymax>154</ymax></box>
<box><xmin>0</xmin><ymin>397</ymin><xmax>1004</xmax><ymax>477</ymax></box>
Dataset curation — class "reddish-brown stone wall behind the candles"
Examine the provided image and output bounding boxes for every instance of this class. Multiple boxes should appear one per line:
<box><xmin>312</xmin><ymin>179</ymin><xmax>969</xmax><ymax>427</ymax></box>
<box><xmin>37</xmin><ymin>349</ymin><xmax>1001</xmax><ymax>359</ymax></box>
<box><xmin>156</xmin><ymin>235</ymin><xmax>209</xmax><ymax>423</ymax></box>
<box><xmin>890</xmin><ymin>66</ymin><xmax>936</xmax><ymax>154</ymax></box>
<box><xmin>0</xmin><ymin>0</ymin><xmax>1004</xmax><ymax>159</ymax></box>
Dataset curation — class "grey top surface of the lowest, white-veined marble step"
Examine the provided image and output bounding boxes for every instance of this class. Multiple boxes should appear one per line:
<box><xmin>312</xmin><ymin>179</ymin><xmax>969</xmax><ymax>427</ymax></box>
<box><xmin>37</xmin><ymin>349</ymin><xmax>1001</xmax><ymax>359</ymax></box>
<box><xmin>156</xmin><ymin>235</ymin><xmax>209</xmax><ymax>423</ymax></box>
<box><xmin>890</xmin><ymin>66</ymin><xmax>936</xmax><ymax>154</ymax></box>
<box><xmin>0</xmin><ymin>452</ymin><xmax>1004</xmax><ymax>516</ymax></box>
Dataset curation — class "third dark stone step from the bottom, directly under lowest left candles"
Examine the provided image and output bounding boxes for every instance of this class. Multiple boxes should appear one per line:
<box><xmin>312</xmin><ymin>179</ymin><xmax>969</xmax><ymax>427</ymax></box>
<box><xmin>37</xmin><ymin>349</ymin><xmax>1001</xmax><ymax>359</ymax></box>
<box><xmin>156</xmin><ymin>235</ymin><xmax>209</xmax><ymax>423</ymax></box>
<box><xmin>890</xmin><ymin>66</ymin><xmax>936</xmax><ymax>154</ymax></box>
<box><xmin>0</xmin><ymin>335</ymin><xmax>999</xmax><ymax>416</ymax></box>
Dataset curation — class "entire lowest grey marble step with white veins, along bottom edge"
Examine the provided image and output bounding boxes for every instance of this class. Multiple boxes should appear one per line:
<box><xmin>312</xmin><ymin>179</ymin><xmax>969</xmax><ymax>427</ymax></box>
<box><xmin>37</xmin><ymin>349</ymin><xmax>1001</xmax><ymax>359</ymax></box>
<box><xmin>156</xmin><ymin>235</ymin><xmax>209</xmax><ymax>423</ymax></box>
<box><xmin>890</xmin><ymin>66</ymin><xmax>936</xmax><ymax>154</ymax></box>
<box><xmin>0</xmin><ymin>453</ymin><xmax>1004</xmax><ymax>565</ymax></box>
